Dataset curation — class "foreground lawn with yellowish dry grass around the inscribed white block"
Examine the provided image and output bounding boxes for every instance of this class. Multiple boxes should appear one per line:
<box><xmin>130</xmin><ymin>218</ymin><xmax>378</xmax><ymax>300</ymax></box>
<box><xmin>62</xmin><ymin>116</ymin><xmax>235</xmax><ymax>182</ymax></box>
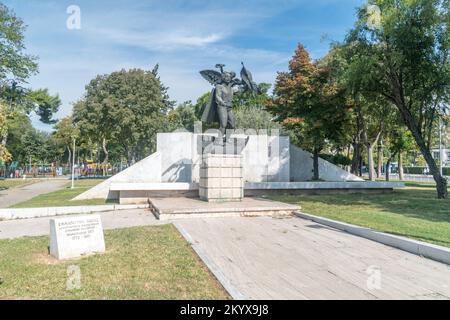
<box><xmin>0</xmin><ymin>224</ymin><xmax>229</xmax><ymax>299</ymax></box>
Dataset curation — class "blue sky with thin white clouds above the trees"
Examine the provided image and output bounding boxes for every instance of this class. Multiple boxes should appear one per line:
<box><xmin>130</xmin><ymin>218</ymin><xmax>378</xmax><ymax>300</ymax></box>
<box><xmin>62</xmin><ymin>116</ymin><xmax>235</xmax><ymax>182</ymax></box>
<box><xmin>2</xmin><ymin>0</ymin><xmax>366</xmax><ymax>130</ymax></box>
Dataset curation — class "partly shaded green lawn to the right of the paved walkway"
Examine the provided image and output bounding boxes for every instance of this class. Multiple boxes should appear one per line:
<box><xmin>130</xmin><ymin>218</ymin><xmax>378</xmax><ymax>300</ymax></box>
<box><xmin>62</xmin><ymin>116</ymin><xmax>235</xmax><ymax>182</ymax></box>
<box><xmin>271</xmin><ymin>183</ymin><xmax>450</xmax><ymax>247</ymax></box>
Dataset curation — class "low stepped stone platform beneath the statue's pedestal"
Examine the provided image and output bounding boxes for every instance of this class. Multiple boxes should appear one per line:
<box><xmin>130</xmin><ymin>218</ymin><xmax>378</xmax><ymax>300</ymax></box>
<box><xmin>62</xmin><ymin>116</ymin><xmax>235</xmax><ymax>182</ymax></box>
<box><xmin>149</xmin><ymin>197</ymin><xmax>300</xmax><ymax>220</ymax></box>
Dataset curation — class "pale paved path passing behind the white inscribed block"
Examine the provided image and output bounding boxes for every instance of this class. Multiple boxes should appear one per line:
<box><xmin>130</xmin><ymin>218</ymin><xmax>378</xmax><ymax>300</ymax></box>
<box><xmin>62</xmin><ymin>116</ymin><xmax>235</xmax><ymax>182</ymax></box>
<box><xmin>0</xmin><ymin>209</ymin><xmax>164</xmax><ymax>239</ymax></box>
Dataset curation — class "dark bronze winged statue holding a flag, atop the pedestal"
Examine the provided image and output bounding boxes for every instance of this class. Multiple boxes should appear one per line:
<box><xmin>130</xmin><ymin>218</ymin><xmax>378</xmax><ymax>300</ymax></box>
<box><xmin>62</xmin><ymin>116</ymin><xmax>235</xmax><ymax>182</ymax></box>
<box><xmin>200</xmin><ymin>63</ymin><xmax>259</xmax><ymax>141</ymax></box>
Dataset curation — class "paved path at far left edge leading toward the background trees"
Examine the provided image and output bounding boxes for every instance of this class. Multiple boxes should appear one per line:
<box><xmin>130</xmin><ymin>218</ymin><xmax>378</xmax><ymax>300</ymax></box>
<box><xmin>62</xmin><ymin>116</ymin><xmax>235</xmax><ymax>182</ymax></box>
<box><xmin>0</xmin><ymin>179</ymin><xmax>69</xmax><ymax>208</ymax></box>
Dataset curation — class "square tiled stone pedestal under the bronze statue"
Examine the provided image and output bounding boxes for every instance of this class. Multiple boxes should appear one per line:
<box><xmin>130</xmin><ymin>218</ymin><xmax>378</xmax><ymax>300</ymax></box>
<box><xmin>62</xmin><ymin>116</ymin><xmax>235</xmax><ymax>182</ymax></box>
<box><xmin>199</xmin><ymin>154</ymin><xmax>244</xmax><ymax>202</ymax></box>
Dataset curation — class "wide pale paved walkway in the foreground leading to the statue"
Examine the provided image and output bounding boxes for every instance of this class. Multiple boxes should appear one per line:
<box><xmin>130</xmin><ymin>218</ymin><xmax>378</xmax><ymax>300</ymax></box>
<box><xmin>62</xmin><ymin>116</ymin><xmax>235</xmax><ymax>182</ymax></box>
<box><xmin>175</xmin><ymin>217</ymin><xmax>450</xmax><ymax>299</ymax></box>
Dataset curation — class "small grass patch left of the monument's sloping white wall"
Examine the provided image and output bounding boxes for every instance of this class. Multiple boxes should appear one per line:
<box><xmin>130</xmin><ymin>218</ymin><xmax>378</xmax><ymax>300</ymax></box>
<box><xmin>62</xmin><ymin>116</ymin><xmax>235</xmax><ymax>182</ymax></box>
<box><xmin>12</xmin><ymin>179</ymin><xmax>111</xmax><ymax>208</ymax></box>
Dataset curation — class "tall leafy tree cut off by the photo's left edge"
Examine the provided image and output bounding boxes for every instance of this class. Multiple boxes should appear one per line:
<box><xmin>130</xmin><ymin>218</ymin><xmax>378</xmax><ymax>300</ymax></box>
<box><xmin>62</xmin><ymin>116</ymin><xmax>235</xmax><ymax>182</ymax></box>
<box><xmin>0</xmin><ymin>3</ymin><xmax>61</xmax><ymax>165</ymax></box>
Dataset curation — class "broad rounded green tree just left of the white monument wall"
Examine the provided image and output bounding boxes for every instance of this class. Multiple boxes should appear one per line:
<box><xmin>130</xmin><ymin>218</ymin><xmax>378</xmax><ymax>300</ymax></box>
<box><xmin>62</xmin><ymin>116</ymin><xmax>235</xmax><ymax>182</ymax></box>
<box><xmin>73</xmin><ymin>69</ymin><xmax>172</xmax><ymax>164</ymax></box>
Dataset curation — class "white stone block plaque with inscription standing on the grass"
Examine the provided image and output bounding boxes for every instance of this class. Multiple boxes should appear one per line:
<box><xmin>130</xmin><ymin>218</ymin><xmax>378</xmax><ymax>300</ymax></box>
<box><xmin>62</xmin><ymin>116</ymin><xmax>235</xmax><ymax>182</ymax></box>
<box><xmin>50</xmin><ymin>215</ymin><xmax>105</xmax><ymax>259</ymax></box>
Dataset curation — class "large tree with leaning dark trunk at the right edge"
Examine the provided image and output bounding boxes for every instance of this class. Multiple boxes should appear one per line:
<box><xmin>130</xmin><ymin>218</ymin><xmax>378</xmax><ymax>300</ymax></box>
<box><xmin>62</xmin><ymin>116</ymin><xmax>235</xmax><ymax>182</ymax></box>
<box><xmin>346</xmin><ymin>0</ymin><xmax>450</xmax><ymax>198</ymax></box>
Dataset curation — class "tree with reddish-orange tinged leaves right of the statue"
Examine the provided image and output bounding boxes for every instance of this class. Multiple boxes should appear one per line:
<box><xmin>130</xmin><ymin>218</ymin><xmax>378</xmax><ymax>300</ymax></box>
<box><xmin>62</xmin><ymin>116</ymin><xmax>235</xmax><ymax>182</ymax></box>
<box><xmin>267</xmin><ymin>44</ymin><xmax>349</xmax><ymax>180</ymax></box>
